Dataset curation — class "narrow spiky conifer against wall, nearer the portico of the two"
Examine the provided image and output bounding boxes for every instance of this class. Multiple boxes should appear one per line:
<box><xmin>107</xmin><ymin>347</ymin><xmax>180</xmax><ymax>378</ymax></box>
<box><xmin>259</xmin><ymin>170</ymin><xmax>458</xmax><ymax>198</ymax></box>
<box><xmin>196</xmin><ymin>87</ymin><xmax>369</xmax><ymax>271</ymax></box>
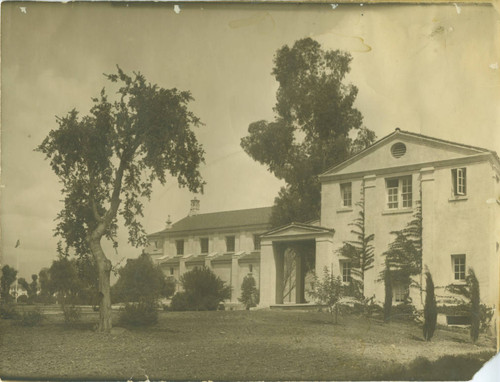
<box><xmin>339</xmin><ymin>192</ymin><xmax>375</xmax><ymax>299</ymax></box>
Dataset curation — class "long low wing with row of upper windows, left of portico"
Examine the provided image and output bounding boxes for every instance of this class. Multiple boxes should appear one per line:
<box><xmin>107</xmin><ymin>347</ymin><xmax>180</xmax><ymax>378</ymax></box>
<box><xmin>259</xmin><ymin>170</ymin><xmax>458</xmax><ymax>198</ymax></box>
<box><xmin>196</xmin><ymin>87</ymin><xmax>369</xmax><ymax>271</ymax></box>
<box><xmin>147</xmin><ymin>198</ymin><xmax>271</xmax><ymax>303</ymax></box>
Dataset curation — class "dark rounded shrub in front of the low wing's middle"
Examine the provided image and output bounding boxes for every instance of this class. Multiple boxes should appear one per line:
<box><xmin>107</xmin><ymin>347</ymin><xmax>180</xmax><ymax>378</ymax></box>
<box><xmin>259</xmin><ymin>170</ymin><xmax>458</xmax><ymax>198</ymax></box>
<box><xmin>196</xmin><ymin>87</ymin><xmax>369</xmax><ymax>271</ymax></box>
<box><xmin>170</xmin><ymin>267</ymin><xmax>231</xmax><ymax>310</ymax></box>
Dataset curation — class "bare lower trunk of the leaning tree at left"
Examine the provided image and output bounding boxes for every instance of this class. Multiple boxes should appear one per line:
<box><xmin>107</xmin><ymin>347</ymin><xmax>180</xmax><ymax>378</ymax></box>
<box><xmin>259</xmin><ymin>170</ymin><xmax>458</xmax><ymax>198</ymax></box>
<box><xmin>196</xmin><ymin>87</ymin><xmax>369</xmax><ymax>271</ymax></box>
<box><xmin>90</xmin><ymin>238</ymin><xmax>111</xmax><ymax>332</ymax></box>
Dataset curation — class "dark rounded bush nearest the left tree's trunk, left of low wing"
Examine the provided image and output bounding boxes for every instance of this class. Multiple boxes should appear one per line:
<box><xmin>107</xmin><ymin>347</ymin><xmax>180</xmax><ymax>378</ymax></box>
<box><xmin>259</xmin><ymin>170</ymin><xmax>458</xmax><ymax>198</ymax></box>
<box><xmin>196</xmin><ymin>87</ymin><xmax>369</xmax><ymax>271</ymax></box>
<box><xmin>111</xmin><ymin>254</ymin><xmax>175</xmax><ymax>303</ymax></box>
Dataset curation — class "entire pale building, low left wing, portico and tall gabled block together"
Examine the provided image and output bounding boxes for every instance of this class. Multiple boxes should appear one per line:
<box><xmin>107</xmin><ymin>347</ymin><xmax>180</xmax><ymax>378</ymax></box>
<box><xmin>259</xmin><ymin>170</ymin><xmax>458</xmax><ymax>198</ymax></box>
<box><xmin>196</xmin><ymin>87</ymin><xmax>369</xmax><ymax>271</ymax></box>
<box><xmin>149</xmin><ymin>129</ymin><xmax>500</xmax><ymax>307</ymax></box>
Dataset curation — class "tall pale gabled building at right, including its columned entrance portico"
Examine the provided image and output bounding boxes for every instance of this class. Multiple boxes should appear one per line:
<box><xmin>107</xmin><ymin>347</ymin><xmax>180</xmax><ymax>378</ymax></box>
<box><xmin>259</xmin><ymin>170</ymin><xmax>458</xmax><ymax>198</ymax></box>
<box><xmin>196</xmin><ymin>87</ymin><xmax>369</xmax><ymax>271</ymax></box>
<box><xmin>260</xmin><ymin>129</ymin><xmax>500</xmax><ymax>306</ymax></box>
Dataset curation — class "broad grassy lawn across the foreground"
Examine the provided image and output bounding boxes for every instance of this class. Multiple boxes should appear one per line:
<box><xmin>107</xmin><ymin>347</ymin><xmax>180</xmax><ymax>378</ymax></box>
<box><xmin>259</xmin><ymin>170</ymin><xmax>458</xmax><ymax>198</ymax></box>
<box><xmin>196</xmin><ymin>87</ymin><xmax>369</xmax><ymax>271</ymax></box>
<box><xmin>0</xmin><ymin>310</ymin><xmax>494</xmax><ymax>380</ymax></box>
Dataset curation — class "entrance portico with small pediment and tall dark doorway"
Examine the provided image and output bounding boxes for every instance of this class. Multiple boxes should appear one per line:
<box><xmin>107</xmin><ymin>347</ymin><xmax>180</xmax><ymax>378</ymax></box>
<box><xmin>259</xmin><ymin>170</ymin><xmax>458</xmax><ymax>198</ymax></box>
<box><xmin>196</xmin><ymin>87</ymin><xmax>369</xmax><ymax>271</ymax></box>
<box><xmin>260</xmin><ymin>223</ymin><xmax>334</xmax><ymax>307</ymax></box>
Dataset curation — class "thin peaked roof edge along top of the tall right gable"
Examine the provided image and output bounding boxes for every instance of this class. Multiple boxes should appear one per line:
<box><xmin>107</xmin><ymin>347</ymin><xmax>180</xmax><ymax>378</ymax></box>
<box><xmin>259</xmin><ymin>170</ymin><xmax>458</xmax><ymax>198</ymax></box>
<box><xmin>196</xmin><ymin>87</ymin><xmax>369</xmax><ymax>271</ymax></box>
<box><xmin>319</xmin><ymin>128</ymin><xmax>500</xmax><ymax>179</ymax></box>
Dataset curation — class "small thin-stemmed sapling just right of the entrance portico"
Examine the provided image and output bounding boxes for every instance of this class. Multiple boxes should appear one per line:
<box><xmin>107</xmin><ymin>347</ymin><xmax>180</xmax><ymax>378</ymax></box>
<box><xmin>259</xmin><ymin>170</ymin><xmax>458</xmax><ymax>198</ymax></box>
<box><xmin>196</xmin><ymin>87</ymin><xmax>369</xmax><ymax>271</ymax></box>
<box><xmin>310</xmin><ymin>267</ymin><xmax>343</xmax><ymax>323</ymax></box>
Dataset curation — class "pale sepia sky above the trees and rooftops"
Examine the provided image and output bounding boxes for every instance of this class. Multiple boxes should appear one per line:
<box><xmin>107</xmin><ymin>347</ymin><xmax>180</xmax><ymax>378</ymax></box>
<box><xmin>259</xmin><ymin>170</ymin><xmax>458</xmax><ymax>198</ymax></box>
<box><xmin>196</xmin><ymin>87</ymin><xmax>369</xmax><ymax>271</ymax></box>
<box><xmin>0</xmin><ymin>3</ymin><xmax>500</xmax><ymax>277</ymax></box>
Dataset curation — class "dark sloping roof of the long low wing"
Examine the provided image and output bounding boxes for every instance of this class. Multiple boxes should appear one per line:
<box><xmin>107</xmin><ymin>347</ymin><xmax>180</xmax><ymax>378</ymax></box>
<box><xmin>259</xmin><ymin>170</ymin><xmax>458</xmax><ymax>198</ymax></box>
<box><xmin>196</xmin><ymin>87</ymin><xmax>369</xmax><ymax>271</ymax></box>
<box><xmin>149</xmin><ymin>207</ymin><xmax>272</xmax><ymax>236</ymax></box>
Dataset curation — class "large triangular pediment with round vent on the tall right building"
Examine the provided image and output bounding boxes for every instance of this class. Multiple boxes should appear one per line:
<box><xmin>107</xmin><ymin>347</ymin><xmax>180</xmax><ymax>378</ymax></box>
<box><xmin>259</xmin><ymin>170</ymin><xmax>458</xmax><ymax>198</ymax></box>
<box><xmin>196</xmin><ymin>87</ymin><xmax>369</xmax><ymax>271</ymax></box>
<box><xmin>320</xmin><ymin>130</ymin><xmax>491</xmax><ymax>178</ymax></box>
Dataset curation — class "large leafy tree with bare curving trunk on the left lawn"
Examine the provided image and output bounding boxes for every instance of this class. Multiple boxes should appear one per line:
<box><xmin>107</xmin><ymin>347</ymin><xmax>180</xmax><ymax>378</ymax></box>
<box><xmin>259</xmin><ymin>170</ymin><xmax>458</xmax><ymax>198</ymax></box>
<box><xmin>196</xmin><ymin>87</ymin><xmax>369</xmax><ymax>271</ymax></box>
<box><xmin>37</xmin><ymin>68</ymin><xmax>204</xmax><ymax>331</ymax></box>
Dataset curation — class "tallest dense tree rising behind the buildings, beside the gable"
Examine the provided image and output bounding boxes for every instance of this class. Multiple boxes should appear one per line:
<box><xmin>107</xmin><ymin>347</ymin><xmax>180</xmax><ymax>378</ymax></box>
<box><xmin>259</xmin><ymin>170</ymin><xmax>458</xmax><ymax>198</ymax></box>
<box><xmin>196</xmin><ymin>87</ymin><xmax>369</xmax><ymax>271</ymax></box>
<box><xmin>241</xmin><ymin>38</ymin><xmax>375</xmax><ymax>225</ymax></box>
